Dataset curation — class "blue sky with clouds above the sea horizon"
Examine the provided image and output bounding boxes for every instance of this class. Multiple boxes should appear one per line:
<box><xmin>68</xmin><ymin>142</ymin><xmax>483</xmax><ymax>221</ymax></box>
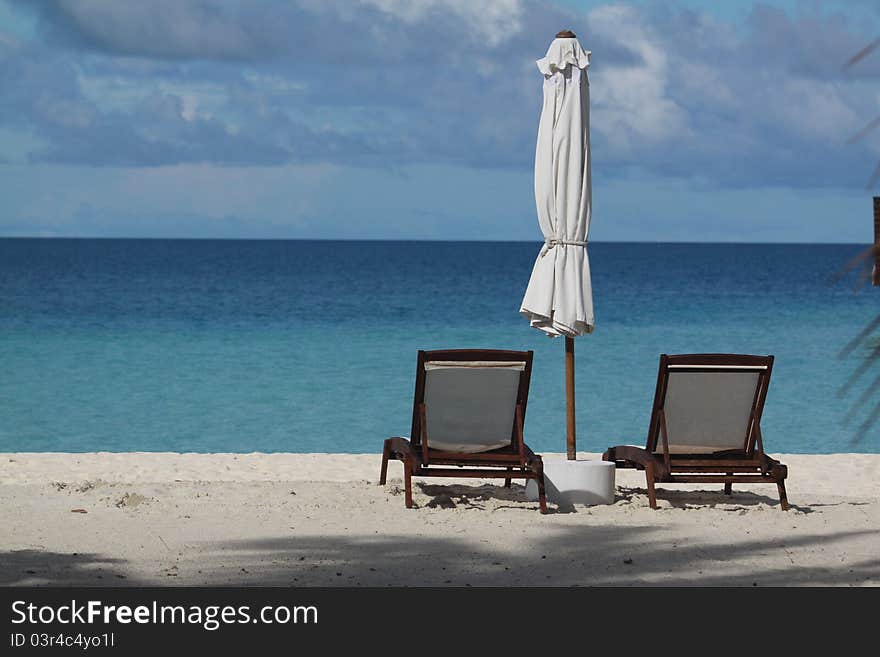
<box><xmin>0</xmin><ymin>0</ymin><xmax>880</xmax><ymax>242</ymax></box>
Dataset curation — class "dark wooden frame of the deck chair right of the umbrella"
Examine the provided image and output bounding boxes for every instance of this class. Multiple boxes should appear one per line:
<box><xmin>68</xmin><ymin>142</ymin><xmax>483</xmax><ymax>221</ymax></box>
<box><xmin>602</xmin><ymin>354</ymin><xmax>789</xmax><ymax>511</ymax></box>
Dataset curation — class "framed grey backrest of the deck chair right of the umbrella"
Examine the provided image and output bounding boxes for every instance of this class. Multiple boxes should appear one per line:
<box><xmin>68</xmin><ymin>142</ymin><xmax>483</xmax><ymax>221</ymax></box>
<box><xmin>649</xmin><ymin>354</ymin><xmax>772</xmax><ymax>454</ymax></box>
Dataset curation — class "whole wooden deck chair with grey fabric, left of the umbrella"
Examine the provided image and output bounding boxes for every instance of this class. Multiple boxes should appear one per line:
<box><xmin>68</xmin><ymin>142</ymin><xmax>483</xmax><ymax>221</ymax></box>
<box><xmin>379</xmin><ymin>349</ymin><xmax>547</xmax><ymax>513</ymax></box>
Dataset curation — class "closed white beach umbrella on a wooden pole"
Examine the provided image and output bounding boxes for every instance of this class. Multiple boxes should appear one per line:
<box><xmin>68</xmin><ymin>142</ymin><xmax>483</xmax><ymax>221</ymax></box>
<box><xmin>520</xmin><ymin>31</ymin><xmax>594</xmax><ymax>459</ymax></box>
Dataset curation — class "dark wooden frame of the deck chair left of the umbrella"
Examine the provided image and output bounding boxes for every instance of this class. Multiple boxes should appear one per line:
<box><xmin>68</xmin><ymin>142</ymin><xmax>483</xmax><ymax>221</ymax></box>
<box><xmin>379</xmin><ymin>349</ymin><xmax>547</xmax><ymax>513</ymax></box>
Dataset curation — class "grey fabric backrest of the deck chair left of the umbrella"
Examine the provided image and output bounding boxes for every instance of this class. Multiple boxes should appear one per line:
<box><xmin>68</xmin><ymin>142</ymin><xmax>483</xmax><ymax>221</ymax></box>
<box><xmin>413</xmin><ymin>352</ymin><xmax>531</xmax><ymax>454</ymax></box>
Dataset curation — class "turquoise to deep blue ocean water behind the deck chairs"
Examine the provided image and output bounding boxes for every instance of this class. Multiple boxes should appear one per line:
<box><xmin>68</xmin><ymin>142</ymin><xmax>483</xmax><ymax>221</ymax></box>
<box><xmin>0</xmin><ymin>239</ymin><xmax>880</xmax><ymax>453</ymax></box>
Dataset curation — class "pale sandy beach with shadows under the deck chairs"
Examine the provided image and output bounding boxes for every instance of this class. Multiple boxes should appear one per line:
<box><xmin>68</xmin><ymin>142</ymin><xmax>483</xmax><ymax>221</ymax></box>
<box><xmin>0</xmin><ymin>453</ymin><xmax>880</xmax><ymax>586</ymax></box>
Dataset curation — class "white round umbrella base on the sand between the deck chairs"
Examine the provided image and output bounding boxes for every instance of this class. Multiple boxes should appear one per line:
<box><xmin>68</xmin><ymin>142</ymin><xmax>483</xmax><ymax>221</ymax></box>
<box><xmin>526</xmin><ymin>458</ymin><xmax>615</xmax><ymax>504</ymax></box>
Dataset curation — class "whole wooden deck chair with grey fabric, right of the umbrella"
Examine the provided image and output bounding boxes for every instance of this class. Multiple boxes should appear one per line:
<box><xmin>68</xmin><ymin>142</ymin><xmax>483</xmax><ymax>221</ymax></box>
<box><xmin>602</xmin><ymin>354</ymin><xmax>788</xmax><ymax>511</ymax></box>
